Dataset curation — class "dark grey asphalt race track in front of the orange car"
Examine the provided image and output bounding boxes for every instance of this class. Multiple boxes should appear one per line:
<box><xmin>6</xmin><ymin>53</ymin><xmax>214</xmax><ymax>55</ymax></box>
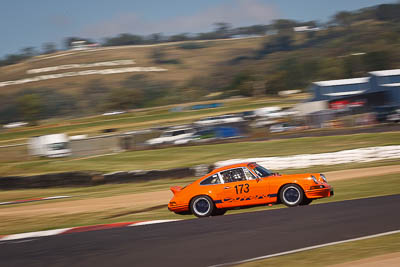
<box><xmin>0</xmin><ymin>194</ymin><xmax>400</xmax><ymax>267</ymax></box>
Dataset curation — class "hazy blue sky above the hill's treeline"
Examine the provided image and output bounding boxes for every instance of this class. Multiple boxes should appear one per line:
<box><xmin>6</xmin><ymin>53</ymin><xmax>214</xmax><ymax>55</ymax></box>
<box><xmin>0</xmin><ymin>0</ymin><xmax>395</xmax><ymax>57</ymax></box>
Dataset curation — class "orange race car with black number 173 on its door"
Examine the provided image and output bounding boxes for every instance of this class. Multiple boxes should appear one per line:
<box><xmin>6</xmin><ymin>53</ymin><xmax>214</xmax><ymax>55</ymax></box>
<box><xmin>168</xmin><ymin>162</ymin><xmax>333</xmax><ymax>217</ymax></box>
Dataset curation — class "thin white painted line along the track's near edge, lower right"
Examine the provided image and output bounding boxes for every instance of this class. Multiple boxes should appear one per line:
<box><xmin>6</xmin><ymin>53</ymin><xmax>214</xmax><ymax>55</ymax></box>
<box><xmin>210</xmin><ymin>230</ymin><xmax>400</xmax><ymax>267</ymax></box>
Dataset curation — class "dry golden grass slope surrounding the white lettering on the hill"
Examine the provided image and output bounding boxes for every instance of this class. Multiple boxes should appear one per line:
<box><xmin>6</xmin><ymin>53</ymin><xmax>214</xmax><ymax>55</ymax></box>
<box><xmin>0</xmin><ymin>38</ymin><xmax>265</xmax><ymax>93</ymax></box>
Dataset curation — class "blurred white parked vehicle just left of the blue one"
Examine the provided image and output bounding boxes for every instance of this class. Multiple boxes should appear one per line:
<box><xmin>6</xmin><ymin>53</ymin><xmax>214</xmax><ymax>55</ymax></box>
<box><xmin>146</xmin><ymin>128</ymin><xmax>195</xmax><ymax>145</ymax></box>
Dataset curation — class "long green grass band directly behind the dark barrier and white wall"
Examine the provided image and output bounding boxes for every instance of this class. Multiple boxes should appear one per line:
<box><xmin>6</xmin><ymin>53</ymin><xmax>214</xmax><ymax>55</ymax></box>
<box><xmin>0</xmin><ymin>132</ymin><xmax>400</xmax><ymax>175</ymax></box>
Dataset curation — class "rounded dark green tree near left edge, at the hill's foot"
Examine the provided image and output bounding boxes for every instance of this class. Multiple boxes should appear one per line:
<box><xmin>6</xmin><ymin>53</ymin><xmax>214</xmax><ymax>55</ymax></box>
<box><xmin>17</xmin><ymin>94</ymin><xmax>42</xmax><ymax>125</ymax></box>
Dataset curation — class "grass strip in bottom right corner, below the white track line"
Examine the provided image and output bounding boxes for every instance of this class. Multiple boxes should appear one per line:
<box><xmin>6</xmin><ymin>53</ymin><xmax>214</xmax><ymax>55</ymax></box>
<box><xmin>239</xmin><ymin>234</ymin><xmax>400</xmax><ymax>267</ymax></box>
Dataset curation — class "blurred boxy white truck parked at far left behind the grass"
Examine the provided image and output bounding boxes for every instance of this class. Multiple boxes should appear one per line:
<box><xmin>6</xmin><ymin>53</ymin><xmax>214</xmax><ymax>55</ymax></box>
<box><xmin>28</xmin><ymin>134</ymin><xmax>71</xmax><ymax>158</ymax></box>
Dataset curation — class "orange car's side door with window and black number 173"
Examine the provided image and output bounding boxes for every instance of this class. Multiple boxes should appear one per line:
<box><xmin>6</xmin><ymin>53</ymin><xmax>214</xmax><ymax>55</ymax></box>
<box><xmin>216</xmin><ymin>167</ymin><xmax>267</xmax><ymax>208</ymax></box>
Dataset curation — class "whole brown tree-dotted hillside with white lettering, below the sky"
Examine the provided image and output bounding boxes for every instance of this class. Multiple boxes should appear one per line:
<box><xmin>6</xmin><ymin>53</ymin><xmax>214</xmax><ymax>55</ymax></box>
<box><xmin>0</xmin><ymin>3</ymin><xmax>400</xmax><ymax>123</ymax></box>
